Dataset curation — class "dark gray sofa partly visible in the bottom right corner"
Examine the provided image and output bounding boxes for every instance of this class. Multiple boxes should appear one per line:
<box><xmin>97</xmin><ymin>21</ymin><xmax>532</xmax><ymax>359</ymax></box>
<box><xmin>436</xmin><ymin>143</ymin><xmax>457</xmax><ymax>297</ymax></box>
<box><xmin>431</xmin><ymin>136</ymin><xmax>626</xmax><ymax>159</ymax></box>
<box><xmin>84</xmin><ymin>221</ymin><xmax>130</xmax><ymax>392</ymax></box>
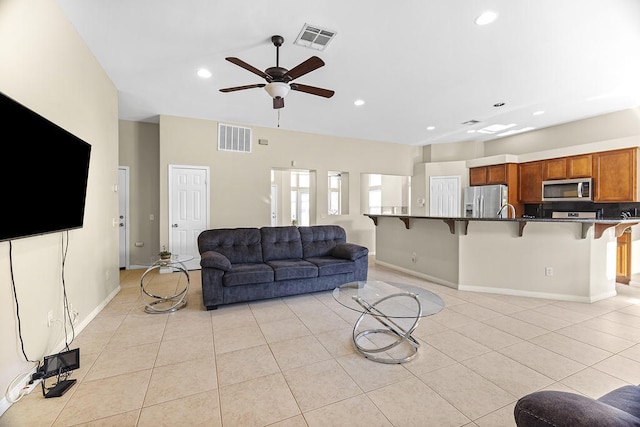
<box><xmin>514</xmin><ymin>385</ymin><xmax>640</xmax><ymax>427</ymax></box>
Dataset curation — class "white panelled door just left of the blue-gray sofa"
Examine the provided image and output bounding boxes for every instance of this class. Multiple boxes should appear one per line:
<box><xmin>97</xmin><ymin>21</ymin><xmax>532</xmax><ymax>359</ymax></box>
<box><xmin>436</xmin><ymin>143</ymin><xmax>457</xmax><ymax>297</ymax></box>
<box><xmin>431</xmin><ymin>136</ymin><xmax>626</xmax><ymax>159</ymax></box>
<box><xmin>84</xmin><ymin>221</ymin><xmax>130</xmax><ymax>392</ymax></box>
<box><xmin>169</xmin><ymin>165</ymin><xmax>209</xmax><ymax>270</ymax></box>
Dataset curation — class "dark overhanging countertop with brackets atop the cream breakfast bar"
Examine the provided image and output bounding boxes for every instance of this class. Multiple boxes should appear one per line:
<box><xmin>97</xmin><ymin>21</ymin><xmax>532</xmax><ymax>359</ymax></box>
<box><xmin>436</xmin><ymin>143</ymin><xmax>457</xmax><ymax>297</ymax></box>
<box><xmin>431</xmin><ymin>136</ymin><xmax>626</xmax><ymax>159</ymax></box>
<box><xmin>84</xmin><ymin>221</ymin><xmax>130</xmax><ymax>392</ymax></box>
<box><xmin>364</xmin><ymin>214</ymin><xmax>640</xmax><ymax>239</ymax></box>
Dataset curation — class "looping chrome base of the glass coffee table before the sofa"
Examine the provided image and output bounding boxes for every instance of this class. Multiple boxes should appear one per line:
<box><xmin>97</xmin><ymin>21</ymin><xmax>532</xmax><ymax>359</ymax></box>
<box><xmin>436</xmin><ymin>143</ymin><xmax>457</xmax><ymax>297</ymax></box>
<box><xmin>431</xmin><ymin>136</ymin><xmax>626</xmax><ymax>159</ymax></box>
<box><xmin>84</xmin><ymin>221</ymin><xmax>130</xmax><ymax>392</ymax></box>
<box><xmin>353</xmin><ymin>292</ymin><xmax>422</xmax><ymax>364</ymax></box>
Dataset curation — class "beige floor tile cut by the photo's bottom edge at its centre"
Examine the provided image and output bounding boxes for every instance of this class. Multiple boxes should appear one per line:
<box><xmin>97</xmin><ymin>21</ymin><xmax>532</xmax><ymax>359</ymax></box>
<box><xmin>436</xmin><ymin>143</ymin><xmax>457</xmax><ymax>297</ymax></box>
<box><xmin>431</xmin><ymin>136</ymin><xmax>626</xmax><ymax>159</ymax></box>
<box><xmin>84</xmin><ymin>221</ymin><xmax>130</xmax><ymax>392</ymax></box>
<box><xmin>304</xmin><ymin>394</ymin><xmax>392</xmax><ymax>427</ymax></box>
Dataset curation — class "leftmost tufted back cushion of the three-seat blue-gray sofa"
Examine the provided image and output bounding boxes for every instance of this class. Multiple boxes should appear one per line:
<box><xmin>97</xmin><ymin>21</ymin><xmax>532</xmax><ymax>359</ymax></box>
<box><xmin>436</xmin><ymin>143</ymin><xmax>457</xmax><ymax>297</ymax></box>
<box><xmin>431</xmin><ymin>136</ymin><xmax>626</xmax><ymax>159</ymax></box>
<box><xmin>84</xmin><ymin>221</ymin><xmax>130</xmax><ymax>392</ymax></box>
<box><xmin>198</xmin><ymin>228</ymin><xmax>263</xmax><ymax>264</ymax></box>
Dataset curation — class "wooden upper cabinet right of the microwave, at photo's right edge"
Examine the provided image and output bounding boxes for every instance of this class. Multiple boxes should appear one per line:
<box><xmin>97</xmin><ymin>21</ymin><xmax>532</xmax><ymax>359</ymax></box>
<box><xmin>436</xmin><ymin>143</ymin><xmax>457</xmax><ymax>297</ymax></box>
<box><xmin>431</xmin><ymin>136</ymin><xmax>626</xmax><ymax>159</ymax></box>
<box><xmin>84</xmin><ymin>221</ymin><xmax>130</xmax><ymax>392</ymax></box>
<box><xmin>593</xmin><ymin>148</ymin><xmax>638</xmax><ymax>202</ymax></box>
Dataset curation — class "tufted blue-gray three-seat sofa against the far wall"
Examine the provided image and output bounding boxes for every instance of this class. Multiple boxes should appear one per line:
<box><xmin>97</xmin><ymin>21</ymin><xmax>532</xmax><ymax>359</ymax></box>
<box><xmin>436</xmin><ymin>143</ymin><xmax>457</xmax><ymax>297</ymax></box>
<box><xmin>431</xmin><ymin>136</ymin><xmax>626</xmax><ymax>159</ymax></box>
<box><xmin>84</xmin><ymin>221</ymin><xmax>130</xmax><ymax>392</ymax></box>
<box><xmin>198</xmin><ymin>225</ymin><xmax>369</xmax><ymax>310</ymax></box>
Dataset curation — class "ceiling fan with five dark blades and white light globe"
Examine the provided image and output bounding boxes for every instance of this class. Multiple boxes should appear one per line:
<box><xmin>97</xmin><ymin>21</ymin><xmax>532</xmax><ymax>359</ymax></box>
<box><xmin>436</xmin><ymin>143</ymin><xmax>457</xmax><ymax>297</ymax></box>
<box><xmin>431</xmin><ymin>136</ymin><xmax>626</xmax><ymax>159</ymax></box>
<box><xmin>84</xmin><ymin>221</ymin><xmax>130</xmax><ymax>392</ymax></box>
<box><xmin>220</xmin><ymin>36</ymin><xmax>335</xmax><ymax>109</ymax></box>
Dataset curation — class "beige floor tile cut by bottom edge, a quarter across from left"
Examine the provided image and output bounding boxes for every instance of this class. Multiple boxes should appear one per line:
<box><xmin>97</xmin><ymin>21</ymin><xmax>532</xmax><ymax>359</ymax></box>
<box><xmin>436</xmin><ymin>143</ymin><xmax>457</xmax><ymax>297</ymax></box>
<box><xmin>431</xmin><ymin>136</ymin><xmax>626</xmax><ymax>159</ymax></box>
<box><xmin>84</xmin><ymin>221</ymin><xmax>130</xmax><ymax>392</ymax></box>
<box><xmin>138</xmin><ymin>390</ymin><xmax>222</xmax><ymax>427</ymax></box>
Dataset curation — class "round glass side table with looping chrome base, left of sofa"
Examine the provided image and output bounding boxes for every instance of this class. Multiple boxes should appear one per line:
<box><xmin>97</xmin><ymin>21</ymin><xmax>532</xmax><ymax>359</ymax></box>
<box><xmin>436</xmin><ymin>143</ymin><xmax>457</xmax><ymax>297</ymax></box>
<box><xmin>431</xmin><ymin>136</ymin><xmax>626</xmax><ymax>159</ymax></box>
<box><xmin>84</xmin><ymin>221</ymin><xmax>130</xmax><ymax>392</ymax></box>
<box><xmin>140</xmin><ymin>255</ymin><xmax>193</xmax><ymax>314</ymax></box>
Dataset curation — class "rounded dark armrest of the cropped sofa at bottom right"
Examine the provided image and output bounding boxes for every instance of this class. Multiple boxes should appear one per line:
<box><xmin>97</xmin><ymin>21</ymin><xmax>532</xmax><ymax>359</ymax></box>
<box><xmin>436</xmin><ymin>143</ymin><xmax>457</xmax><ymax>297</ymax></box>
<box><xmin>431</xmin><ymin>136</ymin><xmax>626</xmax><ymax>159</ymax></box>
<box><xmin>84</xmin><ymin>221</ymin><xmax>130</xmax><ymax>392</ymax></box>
<box><xmin>514</xmin><ymin>390</ymin><xmax>640</xmax><ymax>427</ymax></box>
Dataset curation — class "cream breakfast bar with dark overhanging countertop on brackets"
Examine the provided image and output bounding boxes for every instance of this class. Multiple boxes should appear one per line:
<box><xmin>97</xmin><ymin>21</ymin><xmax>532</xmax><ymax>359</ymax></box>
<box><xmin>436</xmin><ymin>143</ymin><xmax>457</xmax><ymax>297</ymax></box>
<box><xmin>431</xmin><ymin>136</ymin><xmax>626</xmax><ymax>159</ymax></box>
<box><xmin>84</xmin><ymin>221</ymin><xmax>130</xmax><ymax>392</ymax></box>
<box><xmin>365</xmin><ymin>214</ymin><xmax>640</xmax><ymax>302</ymax></box>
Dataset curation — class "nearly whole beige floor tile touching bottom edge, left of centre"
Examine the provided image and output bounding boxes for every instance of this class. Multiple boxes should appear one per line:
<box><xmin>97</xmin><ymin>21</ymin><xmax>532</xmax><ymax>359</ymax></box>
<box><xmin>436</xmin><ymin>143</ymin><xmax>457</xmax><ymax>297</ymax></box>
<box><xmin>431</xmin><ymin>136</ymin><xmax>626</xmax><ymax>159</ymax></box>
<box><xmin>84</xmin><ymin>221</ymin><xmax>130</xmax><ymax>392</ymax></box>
<box><xmin>219</xmin><ymin>373</ymin><xmax>300</xmax><ymax>426</ymax></box>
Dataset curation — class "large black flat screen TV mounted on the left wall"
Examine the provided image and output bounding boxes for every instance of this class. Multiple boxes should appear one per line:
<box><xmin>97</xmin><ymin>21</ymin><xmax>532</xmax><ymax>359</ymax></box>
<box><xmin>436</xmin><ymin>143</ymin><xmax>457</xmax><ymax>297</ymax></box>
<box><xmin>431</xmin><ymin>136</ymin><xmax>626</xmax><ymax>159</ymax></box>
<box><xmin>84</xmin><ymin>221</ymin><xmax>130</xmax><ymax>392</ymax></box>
<box><xmin>0</xmin><ymin>92</ymin><xmax>91</xmax><ymax>241</ymax></box>
